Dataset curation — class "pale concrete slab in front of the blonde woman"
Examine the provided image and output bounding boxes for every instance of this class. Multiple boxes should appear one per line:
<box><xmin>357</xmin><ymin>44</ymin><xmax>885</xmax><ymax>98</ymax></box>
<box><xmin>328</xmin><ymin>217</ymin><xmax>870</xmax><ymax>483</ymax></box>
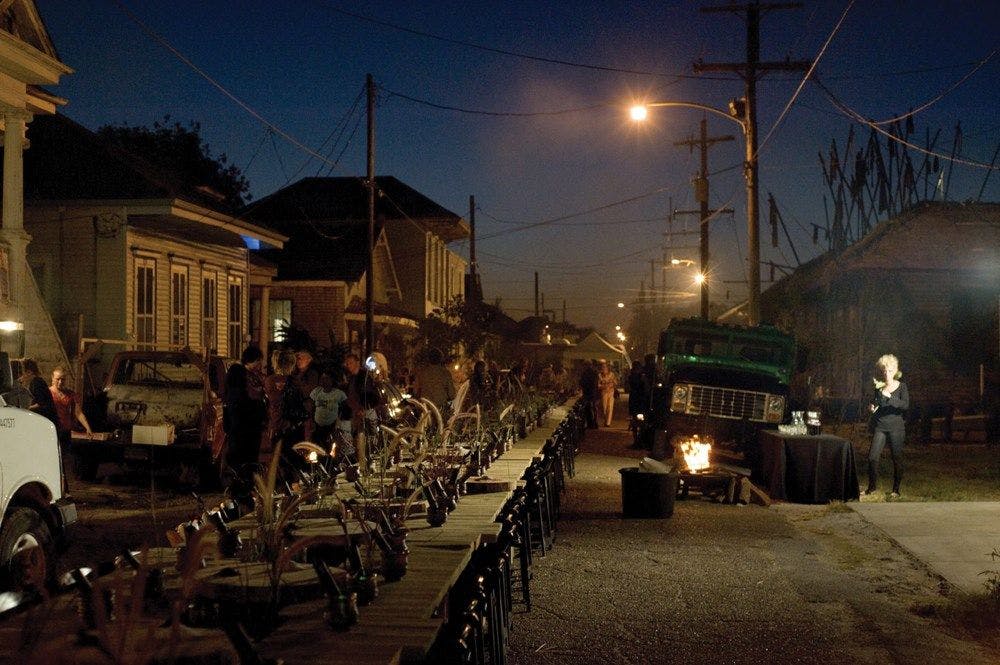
<box><xmin>847</xmin><ymin>501</ymin><xmax>1000</xmax><ymax>593</ymax></box>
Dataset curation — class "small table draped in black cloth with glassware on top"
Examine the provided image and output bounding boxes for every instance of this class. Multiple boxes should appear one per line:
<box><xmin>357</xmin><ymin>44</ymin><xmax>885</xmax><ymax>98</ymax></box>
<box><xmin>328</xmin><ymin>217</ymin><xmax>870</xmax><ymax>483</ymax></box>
<box><xmin>759</xmin><ymin>430</ymin><xmax>859</xmax><ymax>503</ymax></box>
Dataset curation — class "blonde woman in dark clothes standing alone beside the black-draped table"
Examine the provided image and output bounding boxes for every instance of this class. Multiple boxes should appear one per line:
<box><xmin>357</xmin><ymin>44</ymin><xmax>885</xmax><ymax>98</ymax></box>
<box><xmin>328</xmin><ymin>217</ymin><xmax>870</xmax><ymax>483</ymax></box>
<box><xmin>864</xmin><ymin>354</ymin><xmax>910</xmax><ymax>499</ymax></box>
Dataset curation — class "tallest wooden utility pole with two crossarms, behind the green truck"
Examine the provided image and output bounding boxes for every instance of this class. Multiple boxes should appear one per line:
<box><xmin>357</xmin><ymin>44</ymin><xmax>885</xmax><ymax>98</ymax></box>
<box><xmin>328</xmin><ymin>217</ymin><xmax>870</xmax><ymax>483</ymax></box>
<box><xmin>694</xmin><ymin>0</ymin><xmax>812</xmax><ymax>326</ymax></box>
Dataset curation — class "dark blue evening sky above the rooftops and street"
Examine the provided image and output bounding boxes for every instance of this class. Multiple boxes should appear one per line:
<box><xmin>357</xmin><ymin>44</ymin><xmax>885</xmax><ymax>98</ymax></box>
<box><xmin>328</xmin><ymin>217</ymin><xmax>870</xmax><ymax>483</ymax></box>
<box><xmin>37</xmin><ymin>0</ymin><xmax>1000</xmax><ymax>330</ymax></box>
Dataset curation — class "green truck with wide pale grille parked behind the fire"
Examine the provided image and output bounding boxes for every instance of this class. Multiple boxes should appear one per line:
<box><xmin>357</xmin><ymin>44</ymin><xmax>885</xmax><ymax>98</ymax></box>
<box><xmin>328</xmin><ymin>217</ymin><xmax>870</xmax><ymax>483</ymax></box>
<box><xmin>648</xmin><ymin>318</ymin><xmax>795</xmax><ymax>466</ymax></box>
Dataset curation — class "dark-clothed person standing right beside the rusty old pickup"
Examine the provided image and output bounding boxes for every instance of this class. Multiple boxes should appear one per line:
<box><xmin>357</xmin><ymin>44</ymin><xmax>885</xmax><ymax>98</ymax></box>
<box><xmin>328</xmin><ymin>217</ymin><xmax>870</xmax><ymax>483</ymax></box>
<box><xmin>222</xmin><ymin>346</ymin><xmax>267</xmax><ymax>487</ymax></box>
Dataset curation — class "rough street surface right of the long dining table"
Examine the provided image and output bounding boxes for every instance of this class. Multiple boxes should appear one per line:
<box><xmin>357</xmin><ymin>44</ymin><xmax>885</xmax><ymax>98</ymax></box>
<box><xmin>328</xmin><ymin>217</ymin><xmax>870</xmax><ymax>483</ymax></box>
<box><xmin>511</xmin><ymin>412</ymin><xmax>1000</xmax><ymax>664</ymax></box>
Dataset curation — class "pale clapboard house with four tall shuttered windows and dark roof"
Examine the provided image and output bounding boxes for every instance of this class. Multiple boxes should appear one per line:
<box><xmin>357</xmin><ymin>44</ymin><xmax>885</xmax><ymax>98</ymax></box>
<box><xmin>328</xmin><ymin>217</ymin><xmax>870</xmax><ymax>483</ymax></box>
<box><xmin>24</xmin><ymin>116</ymin><xmax>286</xmax><ymax>387</ymax></box>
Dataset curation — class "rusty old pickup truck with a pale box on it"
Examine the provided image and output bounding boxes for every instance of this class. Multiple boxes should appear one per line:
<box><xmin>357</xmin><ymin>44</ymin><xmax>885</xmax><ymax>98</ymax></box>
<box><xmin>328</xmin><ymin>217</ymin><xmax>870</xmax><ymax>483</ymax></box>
<box><xmin>72</xmin><ymin>351</ymin><xmax>229</xmax><ymax>484</ymax></box>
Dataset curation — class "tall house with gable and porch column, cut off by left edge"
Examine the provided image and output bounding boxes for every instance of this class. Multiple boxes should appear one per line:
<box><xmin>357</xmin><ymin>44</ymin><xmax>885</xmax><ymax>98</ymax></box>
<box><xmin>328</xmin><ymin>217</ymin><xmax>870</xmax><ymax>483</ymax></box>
<box><xmin>0</xmin><ymin>0</ymin><xmax>73</xmax><ymax>374</ymax></box>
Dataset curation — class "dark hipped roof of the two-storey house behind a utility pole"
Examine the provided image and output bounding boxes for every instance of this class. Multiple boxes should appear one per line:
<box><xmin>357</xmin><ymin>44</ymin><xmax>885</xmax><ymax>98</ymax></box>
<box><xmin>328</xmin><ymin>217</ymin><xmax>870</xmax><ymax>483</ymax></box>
<box><xmin>241</xmin><ymin>176</ymin><xmax>469</xmax><ymax>242</ymax></box>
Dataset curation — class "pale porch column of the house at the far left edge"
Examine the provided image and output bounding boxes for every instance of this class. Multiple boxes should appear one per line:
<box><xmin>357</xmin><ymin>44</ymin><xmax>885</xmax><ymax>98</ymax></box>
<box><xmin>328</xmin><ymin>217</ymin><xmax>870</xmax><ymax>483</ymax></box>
<box><xmin>0</xmin><ymin>108</ymin><xmax>32</xmax><ymax>323</ymax></box>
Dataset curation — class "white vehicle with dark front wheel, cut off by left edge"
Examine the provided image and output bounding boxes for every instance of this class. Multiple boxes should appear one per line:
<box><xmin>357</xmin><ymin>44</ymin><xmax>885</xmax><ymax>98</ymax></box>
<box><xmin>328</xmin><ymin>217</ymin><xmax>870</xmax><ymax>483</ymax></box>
<box><xmin>0</xmin><ymin>400</ymin><xmax>76</xmax><ymax>589</ymax></box>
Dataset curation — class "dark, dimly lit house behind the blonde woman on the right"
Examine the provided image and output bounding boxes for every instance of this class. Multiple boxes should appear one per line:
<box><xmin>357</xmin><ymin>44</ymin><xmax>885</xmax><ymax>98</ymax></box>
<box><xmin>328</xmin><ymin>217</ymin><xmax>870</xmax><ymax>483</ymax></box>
<box><xmin>761</xmin><ymin>203</ymin><xmax>1000</xmax><ymax>408</ymax></box>
